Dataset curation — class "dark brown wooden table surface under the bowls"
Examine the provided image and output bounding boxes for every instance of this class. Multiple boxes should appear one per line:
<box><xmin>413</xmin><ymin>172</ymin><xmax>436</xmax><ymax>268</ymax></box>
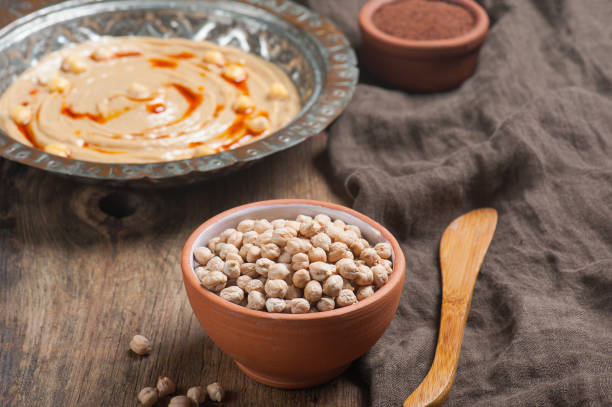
<box><xmin>0</xmin><ymin>0</ymin><xmax>368</xmax><ymax>407</ymax></box>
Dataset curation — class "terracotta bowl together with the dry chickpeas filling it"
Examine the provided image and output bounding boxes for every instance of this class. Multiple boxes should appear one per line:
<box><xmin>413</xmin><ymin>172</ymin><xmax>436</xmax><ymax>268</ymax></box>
<box><xmin>181</xmin><ymin>199</ymin><xmax>406</xmax><ymax>388</ymax></box>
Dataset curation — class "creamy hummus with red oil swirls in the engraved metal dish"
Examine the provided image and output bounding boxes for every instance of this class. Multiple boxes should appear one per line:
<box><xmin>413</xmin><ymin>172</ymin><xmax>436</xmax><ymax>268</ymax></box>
<box><xmin>0</xmin><ymin>37</ymin><xmax>300</xmax><ymax>163</ymax></box>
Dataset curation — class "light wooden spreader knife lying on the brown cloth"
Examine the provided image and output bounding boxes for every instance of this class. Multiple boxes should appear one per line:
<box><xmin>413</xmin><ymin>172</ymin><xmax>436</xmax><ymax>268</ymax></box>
<box><xmin>404</xmin><ymin>208</ymin><xmax>497</xmax><ymax>407</ymax></box>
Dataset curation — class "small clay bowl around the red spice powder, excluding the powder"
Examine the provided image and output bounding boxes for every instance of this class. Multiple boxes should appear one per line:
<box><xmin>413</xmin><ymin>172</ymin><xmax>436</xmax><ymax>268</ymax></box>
<box><xmin>359</xmin><ymin>0</ymin><xmax>489</xmax><ymax>92</ymax></box>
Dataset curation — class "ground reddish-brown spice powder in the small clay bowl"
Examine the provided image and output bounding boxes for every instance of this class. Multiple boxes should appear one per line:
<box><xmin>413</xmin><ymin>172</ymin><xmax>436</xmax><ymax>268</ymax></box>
<box><xmin>372</xmin><ymin>0</ymin><xmax>474</xmax><ymax>40</ymax></box>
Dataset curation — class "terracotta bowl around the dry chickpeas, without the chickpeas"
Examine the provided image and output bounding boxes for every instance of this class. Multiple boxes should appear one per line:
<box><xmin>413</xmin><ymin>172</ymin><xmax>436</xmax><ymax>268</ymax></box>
<box><xmin>181</xmin><ymin>199</ymin><xmax>406</xmax><ymax>389</ymax></box>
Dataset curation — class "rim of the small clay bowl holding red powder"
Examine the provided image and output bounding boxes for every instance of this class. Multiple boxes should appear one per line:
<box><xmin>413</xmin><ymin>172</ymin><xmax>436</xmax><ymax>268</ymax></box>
<box><xmin>359</xmin><ymin>0</ymin><xmax>489</xmax><ymax>53</ymax></box>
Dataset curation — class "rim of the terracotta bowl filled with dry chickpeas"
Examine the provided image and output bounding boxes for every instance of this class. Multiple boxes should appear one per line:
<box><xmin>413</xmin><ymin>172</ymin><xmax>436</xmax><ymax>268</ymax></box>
<box><xmin>181</xmin><ymin>199</ymin><xmax>406</xmax><ymax>320</ymax></box>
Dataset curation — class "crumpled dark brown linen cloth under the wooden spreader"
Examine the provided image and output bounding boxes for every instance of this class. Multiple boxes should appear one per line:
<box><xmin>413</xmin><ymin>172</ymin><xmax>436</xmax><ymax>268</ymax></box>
<box><xmin>304</xmin><ymin>0</ymin><xmax>612</xmax><ymax>406</ymax></box>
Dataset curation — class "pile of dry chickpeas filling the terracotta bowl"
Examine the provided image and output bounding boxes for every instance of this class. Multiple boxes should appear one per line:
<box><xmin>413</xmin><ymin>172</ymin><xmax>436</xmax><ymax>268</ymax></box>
<box><xmin>193</xmin><ymin>214</ymin><xmax>393</xmax><ymax>314</ymax></box>
